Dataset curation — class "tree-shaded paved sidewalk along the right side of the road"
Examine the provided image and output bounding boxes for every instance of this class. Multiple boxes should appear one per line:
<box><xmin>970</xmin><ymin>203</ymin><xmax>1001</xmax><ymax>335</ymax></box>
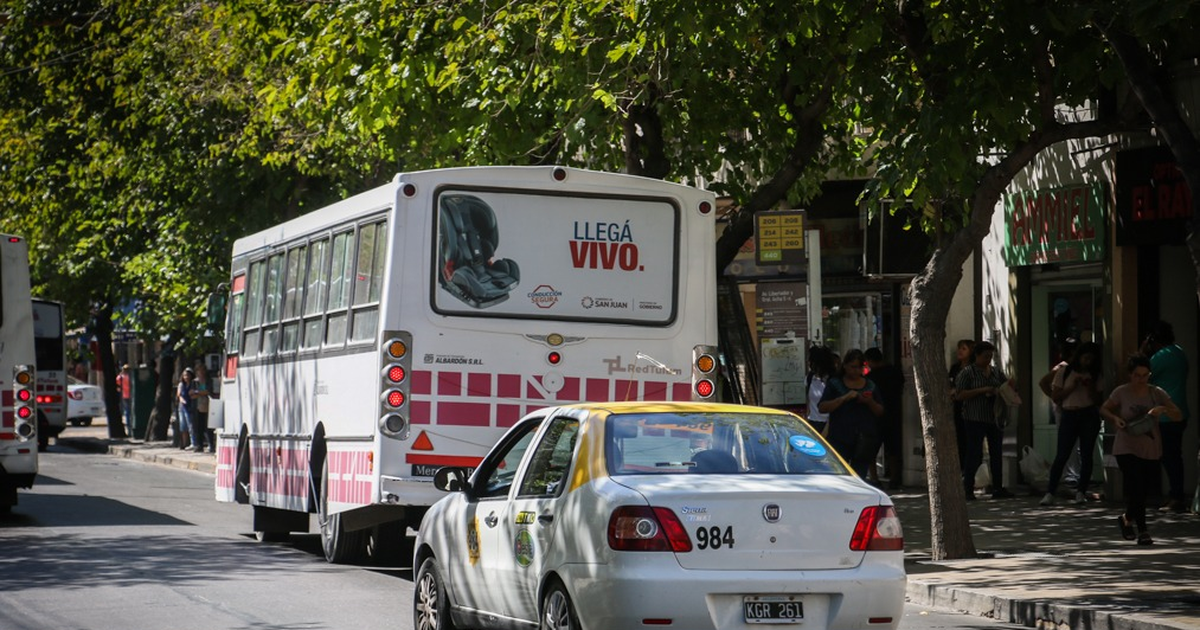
<box><xmin>60</xmin><ymin>425</ymin><xmax>1200</xmax><ymax>630</ymax></box>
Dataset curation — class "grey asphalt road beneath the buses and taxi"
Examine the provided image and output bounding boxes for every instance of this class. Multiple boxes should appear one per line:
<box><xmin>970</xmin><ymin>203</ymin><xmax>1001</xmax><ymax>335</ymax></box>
<box><xmin>0</xmin><ymin>445</ymin><xmax>1032</xmax><ymax>630</ymax></box>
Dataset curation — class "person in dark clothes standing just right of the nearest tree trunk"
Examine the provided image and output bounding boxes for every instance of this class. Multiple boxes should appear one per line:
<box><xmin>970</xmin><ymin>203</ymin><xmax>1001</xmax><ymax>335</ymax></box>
<box><xmin>955</xmin><ymin>341</ymin><xmax>1013</xmax><ymax>500</ymax></box>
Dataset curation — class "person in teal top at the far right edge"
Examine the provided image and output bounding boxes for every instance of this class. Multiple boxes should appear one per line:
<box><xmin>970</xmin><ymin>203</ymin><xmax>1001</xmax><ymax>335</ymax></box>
<box><xmin>1141</xmin><ymin>322</ymin><xmax>1188</xmax><ymax>512</ymax></box>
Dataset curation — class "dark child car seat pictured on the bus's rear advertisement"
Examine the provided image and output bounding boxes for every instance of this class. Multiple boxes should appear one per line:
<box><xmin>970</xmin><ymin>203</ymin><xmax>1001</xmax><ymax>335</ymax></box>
<box><xmin>438</xmin><ymin>194</ymin><xmax>521</xmax><ymax>308</ymax></box>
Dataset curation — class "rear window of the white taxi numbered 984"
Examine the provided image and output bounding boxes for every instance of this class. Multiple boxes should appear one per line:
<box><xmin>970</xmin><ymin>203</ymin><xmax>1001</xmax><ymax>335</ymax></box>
<box><xmin>605</xmin><ymin>413</ymin><xmax>850</xmax><ymax>475</ymax></box>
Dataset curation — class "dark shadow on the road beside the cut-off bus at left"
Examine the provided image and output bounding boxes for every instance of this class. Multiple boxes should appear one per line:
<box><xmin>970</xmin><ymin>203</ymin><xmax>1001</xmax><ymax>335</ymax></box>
<box><xmin>0</xmin><ymin>494</ymin><xmax>192</xmax><ymax>529</ymax></box>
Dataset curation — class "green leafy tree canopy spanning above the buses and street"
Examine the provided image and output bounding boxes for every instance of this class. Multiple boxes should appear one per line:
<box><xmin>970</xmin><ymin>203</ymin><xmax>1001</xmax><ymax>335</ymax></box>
<box><xmin>0</xmin><ymin>0</ymin><xmax>1195</xmax><ymax>357</ymax></box>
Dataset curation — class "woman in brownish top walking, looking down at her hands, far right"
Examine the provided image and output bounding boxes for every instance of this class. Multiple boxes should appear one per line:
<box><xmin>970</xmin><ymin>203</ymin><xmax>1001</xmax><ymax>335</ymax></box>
<box><xmin>1100</xmin><ymin>354</ymin><xmax>1183</xmax><ymax>545</ymax></box>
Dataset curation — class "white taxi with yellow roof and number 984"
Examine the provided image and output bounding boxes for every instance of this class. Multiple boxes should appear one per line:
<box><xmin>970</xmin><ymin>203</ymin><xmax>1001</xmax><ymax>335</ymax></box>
<box><xmin>413</xmin><ymin>402</ymin><xmax>906</xmax><ymax>630</ymax></box>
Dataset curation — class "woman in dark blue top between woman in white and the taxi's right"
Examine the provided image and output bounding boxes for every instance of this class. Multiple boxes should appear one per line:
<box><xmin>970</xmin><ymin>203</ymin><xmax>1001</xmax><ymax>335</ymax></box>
<box><xmin>817</xmin><ymin>349</ymin><xmax>887</xmax><ymax>479</ymax></box>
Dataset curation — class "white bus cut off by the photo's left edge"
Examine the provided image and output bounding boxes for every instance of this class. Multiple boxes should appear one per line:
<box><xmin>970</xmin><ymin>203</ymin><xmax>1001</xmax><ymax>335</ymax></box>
<box><xmin>0</xmin><ymin>234</ymin><xmax>37</xmax><ymax>514</ymax></box>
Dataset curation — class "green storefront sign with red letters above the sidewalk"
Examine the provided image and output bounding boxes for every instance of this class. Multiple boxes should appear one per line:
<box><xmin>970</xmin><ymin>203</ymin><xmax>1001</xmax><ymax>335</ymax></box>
<box><xmin>1003</xmin><ymin>182</ymin><xmax>1110</xmax><ymax>266</ymax></box>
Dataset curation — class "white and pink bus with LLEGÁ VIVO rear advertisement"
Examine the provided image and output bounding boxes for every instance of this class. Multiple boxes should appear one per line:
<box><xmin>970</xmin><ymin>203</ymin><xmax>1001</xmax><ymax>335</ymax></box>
<box><xmin>209</xmin><ymin>167</ymin><xmax>716</xmax><ymax>562</ymax></box>
